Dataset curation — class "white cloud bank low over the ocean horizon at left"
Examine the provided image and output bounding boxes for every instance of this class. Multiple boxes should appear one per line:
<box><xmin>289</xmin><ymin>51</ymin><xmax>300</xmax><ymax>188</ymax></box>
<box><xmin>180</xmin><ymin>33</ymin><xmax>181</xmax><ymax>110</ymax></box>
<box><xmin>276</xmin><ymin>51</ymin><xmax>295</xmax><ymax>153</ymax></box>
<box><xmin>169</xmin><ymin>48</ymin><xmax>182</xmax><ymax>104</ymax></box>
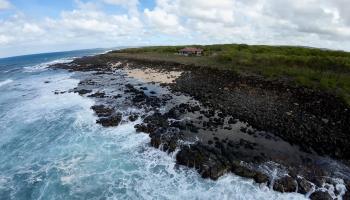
<box><xmin>0</xmin><ymin>1</ymin><xmax>144</xmax><ymax>57</ymax></box>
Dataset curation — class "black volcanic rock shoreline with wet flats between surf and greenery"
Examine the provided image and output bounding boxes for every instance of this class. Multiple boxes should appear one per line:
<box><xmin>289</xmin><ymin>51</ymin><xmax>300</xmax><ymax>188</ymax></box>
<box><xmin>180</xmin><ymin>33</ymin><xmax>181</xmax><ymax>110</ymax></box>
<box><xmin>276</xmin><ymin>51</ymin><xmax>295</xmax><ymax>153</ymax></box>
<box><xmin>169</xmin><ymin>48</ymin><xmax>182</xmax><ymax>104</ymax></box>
<box><xmin>53</xmin><ymin>54</ymin><xmax>350</xmax><ymax>199</ymax></box>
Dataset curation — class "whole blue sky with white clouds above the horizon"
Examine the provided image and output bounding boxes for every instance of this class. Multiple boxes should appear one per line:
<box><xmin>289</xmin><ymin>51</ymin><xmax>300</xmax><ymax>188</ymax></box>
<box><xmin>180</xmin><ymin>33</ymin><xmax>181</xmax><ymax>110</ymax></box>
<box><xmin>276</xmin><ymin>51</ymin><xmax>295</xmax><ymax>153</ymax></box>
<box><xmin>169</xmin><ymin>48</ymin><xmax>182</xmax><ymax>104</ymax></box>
<box><xmin>0</xmin><ymin>0</ymin><xmax>350</xmax><ymax>57</ymax></box>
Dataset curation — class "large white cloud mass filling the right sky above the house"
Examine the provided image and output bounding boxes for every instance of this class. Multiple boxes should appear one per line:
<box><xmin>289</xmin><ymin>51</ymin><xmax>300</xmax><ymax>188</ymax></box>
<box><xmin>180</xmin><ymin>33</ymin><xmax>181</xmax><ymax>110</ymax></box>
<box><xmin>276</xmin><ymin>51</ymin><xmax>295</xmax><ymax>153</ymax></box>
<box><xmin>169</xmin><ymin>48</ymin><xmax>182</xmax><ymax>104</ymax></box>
<box><xmin>144</xmin><ymin>0</ymin><xmax>350</xmax><ymax>50</ymax></box>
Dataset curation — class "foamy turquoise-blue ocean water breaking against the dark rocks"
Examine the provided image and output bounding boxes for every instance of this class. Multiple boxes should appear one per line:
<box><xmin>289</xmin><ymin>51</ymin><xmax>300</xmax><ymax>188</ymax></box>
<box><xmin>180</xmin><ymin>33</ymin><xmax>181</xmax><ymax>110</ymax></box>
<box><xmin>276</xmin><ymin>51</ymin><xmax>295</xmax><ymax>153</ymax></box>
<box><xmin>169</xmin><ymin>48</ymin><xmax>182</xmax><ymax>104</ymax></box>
<box><xmin>0</xmin><ymin>49</ymin><xmax>305</xmax><ymax>200</ymax></box>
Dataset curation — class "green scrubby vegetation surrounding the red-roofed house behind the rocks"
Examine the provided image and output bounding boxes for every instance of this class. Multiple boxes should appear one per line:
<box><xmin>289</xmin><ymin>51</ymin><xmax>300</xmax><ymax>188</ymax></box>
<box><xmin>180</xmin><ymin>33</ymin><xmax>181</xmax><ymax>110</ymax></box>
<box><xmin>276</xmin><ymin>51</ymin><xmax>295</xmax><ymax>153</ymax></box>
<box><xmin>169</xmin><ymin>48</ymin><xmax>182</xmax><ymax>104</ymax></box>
<box><xmin>110</xmin><ymin>44</ymin><xmax>350</xmax><ymax>105</ymax></box>
